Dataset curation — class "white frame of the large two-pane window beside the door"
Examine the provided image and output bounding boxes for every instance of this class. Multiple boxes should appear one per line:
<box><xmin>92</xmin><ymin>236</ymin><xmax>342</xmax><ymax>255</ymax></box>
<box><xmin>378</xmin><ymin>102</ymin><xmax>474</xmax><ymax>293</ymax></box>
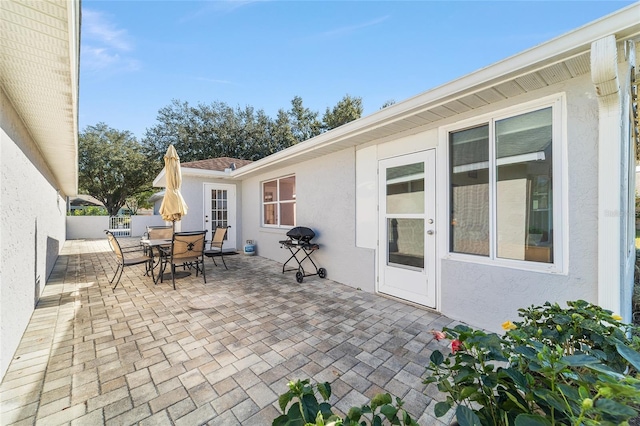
<box><xmin>438</xmin><ymin>93</ymin><xmax>569</xmax><ymax>275</ymax></box>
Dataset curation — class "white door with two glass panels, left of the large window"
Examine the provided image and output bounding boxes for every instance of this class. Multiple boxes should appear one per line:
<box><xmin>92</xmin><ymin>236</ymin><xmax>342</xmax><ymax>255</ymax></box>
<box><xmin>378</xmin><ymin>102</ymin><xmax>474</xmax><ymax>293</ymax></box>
<box><xmin>378</xmin><ymin>149</ymin><xmax>436</xmax><ymax>308</ymax></box>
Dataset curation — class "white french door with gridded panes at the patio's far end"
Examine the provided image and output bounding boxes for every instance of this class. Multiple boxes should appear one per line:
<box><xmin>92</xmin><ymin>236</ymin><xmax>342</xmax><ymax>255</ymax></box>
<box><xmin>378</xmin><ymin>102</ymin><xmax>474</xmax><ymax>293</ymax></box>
<box><xmin>203</xmin><ymin>183</ymin><xmax>237</xmax><ymax>251</ymax></box>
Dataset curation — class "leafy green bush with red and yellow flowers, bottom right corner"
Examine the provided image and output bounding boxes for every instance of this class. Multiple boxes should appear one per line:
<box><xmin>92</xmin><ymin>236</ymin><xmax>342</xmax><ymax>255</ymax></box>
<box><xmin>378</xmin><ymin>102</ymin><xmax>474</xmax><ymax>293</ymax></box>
<box><xmin>425</xmin><ymin>300</ymin><xmax>640</xmax><ymax>426</ymax></box>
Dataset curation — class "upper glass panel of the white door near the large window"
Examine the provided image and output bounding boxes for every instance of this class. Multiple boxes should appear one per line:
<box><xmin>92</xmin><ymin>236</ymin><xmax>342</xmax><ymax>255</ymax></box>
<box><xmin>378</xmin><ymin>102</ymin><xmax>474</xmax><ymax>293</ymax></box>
<box><xmin>387</xmin><ymin>163</ymin><xmax>424</xmax><ymax>214</ymax></box>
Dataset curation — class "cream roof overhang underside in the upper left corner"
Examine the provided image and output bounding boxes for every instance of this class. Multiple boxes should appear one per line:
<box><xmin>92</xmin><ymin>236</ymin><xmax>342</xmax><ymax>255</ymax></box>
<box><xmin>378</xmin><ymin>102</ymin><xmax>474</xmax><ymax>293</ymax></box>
<box><xmin>0</xmin><ymin>0</ymin><xmax>80</xmax><ymax>195</ymax></box>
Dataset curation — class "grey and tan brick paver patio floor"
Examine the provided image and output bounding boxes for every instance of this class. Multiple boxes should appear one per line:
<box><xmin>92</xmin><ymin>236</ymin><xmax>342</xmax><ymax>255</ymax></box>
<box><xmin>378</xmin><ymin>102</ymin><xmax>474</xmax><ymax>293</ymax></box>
<box><xmin>0</xmin><ymin>239</ymin><xmax>458</xmax><ymax>425</ymax></box>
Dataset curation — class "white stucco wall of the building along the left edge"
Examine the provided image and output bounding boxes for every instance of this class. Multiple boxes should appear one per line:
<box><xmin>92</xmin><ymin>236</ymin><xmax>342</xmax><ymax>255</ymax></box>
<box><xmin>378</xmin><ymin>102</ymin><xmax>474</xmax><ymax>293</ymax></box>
<box><xmin>0</xmin><ymin>90</ymin><xmax>66</xmax><ymax>377</ymax></box>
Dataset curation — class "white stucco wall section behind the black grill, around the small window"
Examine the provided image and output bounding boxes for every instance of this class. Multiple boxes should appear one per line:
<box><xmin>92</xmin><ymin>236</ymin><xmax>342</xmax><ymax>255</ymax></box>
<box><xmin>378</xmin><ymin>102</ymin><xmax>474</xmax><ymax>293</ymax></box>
<box><xmin>239</xmin><ymin>149</ymin><xmax>375</xmax><ymax>292</ymax></box>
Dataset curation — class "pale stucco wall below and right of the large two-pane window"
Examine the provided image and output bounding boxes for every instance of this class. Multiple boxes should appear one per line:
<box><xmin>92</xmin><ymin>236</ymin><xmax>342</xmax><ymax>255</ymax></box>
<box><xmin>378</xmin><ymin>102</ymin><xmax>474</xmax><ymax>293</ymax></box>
<box><xmin>440</xmin><ymin>75</ymin><xmax>598</xmax><ymax>331</ymax></box>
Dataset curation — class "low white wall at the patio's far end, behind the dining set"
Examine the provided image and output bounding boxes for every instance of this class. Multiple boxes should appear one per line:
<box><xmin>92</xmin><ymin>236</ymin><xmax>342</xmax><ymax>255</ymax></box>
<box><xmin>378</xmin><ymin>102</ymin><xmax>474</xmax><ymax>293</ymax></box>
<box><xmin>67</xmin><ymin>215</ymin><xmax>170</xmax><ymax>240</ymax></box>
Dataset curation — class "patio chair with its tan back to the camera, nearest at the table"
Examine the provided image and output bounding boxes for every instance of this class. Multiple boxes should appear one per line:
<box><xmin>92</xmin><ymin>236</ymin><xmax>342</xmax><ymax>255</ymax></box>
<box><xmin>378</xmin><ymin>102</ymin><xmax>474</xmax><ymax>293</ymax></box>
<box><xmin>160</xmin><ymin>231</ymin><xmax>207</xmax><ymax>290</ymax></box>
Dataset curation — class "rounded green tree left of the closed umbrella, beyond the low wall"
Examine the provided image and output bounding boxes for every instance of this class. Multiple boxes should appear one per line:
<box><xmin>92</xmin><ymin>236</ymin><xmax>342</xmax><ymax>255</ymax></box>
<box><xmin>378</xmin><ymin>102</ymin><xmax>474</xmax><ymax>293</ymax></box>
<box><xmin>78</xmin><ymin>123</ymin><xmax>155</xmax><ymax>216</ymax></box>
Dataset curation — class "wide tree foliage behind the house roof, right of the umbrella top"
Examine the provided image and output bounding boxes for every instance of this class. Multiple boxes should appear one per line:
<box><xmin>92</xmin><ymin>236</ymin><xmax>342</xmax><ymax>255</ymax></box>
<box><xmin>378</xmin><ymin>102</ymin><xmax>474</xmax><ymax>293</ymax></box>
<box><xmin>142</xmin><ymin>95</ymin><xmax>362</xmax><ymax>165</ymax></box>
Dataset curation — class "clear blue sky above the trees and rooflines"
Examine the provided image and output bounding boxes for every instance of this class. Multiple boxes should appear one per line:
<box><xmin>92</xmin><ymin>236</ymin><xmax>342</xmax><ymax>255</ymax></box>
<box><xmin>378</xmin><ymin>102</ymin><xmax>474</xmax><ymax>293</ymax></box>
<box><xmin>79</xmin><ymin>0</ymin><xmax>633</xmax><ymax>138</ymax></box>
